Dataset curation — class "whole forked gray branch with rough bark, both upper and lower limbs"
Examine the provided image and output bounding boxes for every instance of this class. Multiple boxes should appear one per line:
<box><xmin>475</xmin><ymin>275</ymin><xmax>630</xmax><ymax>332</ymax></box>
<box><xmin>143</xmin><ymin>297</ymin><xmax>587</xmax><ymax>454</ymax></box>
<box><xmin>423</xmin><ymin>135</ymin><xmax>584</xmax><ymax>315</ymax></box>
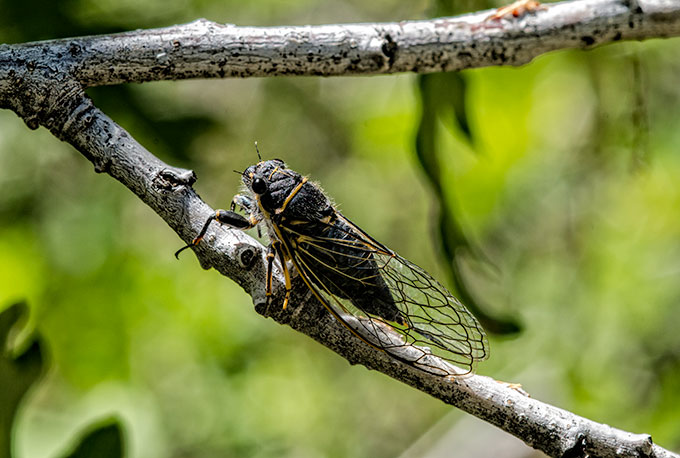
<box><xmin>0</xmin><ymin>0</ymin><xmax>680</xmax><ymax>457</ymax></box>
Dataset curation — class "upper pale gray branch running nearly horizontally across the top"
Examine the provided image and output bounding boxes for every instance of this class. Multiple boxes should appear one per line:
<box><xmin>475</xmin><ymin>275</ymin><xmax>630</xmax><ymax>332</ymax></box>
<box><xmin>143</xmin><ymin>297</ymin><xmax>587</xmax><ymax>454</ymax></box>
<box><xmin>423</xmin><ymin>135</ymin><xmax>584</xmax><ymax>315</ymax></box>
<box><xmin>0</xmin><ymin>0</ymin><xmax>680</xmax><ymax>87</ymax></box>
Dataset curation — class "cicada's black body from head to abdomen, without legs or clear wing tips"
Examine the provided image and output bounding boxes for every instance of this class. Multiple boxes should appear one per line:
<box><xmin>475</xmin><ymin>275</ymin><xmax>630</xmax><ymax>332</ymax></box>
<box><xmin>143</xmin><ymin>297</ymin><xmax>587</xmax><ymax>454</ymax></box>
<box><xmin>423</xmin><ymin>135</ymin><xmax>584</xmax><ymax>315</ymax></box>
<box><xmin>252</xmin><ymin>161</ymin><xmax>404</xmax><ymax>324</ymax></box>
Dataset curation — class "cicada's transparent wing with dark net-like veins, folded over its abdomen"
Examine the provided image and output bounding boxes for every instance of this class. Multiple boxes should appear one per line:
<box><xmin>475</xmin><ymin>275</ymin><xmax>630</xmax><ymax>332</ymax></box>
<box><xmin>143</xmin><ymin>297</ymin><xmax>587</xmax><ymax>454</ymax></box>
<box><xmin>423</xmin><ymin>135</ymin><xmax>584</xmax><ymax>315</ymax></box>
<box><xmin>280</xmin><ymin>213</ymin><xmax>489</xmax><ymax>375</ymax></box>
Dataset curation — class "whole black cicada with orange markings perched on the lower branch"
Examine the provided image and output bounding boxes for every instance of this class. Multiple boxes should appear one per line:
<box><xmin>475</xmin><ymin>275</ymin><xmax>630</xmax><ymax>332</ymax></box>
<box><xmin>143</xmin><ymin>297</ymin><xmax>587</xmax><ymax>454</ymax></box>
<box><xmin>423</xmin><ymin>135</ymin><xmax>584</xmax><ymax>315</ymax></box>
<box><xmin>175</xmin><ymin>159</ymin><xmax>489</xmax><ymax>375</ymax></box>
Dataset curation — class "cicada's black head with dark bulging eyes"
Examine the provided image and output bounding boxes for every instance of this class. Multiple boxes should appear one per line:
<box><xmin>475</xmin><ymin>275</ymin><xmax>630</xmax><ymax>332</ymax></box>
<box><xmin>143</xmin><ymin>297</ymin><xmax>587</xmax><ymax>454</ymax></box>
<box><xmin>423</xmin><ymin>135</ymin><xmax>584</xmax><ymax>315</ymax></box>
<box><xmin>243</xmin><ymin>159</ymin><xmax>303</xmax><ymax>213</ymax></box>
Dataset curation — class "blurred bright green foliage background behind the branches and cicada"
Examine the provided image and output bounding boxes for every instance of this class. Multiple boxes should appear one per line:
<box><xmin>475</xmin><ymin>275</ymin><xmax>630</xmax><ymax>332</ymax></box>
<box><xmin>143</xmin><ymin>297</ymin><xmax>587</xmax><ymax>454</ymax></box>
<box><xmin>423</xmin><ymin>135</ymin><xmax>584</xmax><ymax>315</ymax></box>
<box><xmin>0</xmin><ymin>0</ymin><xmax>680</xmax><ymax>458</ymax></box>
